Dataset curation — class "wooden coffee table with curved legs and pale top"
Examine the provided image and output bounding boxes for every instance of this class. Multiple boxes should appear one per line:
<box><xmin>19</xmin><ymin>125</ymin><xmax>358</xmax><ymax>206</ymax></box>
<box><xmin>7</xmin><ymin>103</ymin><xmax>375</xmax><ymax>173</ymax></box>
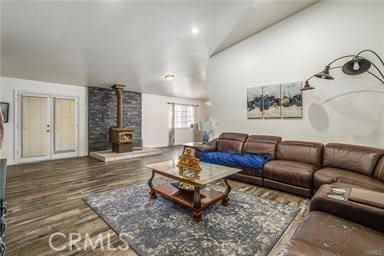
<box><xmin>145</xmin><ymin>160</ymin><xmax>241</xmax><ymax>222</ymax></box>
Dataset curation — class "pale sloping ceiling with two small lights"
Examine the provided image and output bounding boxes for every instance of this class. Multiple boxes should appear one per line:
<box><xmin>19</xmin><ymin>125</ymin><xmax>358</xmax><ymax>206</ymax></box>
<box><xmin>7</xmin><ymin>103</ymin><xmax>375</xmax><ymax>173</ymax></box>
<box><xmin>0</xmin><ymin>0</ymin><xmax>316</xmax><ymax>99</ymax></box>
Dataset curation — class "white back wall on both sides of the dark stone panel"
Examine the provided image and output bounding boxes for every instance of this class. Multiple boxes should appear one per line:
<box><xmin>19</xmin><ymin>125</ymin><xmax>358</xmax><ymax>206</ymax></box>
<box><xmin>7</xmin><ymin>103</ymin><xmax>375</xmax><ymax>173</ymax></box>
<box><xmin>0</xmin><ymin>77</ymin><xmax>208</xmax><ymax>164</ymax></box>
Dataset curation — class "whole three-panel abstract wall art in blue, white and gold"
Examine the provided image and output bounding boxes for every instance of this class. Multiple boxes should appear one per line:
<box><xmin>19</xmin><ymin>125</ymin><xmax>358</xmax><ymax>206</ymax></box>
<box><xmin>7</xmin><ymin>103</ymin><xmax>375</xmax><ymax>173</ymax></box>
<box><xmin>247</xmin><ymin>82</ymin><xmax>303</xmax><ymax>119</ymax></box>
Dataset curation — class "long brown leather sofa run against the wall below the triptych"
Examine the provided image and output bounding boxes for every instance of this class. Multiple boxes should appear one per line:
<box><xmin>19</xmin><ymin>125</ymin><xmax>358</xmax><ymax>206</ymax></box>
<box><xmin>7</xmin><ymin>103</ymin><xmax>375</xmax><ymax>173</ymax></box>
<box><xmin>196</xmin><ymin>133</ymin><xmax>384</xmax><ymax>197</ymax></box>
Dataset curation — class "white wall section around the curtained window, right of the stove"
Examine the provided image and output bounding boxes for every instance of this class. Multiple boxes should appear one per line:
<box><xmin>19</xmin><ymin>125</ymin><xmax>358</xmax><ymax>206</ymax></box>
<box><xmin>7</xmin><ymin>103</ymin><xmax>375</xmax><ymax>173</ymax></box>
<box><xmin>142</xmin><ymin>93</ymin><xmax>208</xmax><ymax>147</ymax></box>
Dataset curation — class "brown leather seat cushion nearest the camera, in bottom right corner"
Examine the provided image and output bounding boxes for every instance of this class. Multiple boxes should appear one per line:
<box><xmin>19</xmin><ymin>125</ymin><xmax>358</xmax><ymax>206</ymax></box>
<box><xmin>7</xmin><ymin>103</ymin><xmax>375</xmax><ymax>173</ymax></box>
<box><xmin>293</xmin><ymin>211</ymin><xmax>384</xmax><ymax>255</ymax></box>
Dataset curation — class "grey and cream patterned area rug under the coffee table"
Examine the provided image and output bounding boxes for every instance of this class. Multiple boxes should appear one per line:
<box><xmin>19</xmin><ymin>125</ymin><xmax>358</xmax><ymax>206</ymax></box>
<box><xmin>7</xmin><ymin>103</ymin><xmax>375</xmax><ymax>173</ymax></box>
<box><xmin>84</xmin><ymin>181</ymin><xmax>298</xmax><ymax>256</ymax></box>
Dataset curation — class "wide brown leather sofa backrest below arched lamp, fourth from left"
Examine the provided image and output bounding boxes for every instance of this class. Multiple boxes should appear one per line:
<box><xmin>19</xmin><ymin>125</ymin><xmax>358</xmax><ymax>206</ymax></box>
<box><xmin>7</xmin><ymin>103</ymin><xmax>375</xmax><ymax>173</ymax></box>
<box><xmin>323</xmin><ymin>143</ymin><xmax>384</xmax><ymax>176</ymax></box>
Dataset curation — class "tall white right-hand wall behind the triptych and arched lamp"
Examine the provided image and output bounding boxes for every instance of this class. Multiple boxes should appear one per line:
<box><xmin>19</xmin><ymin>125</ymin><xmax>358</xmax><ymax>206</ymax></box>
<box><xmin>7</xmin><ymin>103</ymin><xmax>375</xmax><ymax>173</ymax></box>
<box><xmin>208</xmin><ymin>1</ymin><xmax>384</xmax><ymax>147</ymax></box>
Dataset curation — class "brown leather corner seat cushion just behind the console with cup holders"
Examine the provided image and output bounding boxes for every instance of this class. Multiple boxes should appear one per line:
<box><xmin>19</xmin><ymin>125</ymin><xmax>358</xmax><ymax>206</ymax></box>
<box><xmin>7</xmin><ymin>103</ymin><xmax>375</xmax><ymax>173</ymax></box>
<box><xmin>313</xmin><ymin>167</ymin><xmax>384</xmax><ymax>190</ymax></box>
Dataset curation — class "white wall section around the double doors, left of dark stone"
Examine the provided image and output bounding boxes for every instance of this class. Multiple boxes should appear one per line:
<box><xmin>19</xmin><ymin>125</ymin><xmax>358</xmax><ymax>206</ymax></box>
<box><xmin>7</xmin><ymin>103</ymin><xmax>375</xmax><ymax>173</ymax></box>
<box><xmin>0</xmin><ymin>77</ymin><xmax>88</xmax><ymax>164</ymax></box>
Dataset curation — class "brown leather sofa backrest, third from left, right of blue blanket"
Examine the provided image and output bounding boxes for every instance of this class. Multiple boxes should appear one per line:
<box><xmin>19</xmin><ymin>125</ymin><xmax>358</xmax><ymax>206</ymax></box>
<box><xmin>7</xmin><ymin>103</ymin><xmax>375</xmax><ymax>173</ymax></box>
<box><xmin>276</xmin><ymin>141</ymin><xmax>323</xmax><ymax>167</ymax></box>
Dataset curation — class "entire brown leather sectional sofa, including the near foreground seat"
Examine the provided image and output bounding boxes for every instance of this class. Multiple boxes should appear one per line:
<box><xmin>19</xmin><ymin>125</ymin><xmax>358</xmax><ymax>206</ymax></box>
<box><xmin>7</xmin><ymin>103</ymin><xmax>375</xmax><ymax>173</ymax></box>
<box><xmin>196</xmin><ymin>133</ymin><xmax>384</xmax><ymax>256</ymax></box>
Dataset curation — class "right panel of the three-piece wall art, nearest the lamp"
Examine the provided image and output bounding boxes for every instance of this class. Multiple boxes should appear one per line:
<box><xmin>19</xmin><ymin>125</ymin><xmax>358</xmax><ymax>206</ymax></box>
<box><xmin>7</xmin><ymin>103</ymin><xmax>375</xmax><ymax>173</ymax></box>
<box><xmin>281</xmin><ymin>82</ymin><xmax>303</xmax><ymax>118</ymax></box>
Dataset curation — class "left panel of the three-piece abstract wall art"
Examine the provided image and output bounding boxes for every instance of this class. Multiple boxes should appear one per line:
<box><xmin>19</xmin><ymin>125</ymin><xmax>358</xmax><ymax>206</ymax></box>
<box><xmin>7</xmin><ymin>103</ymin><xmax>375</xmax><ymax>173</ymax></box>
<box><xmin>247</xmin><ymin>86</ymin><xmax>263</xmax><ymax>119</ymax></box>
